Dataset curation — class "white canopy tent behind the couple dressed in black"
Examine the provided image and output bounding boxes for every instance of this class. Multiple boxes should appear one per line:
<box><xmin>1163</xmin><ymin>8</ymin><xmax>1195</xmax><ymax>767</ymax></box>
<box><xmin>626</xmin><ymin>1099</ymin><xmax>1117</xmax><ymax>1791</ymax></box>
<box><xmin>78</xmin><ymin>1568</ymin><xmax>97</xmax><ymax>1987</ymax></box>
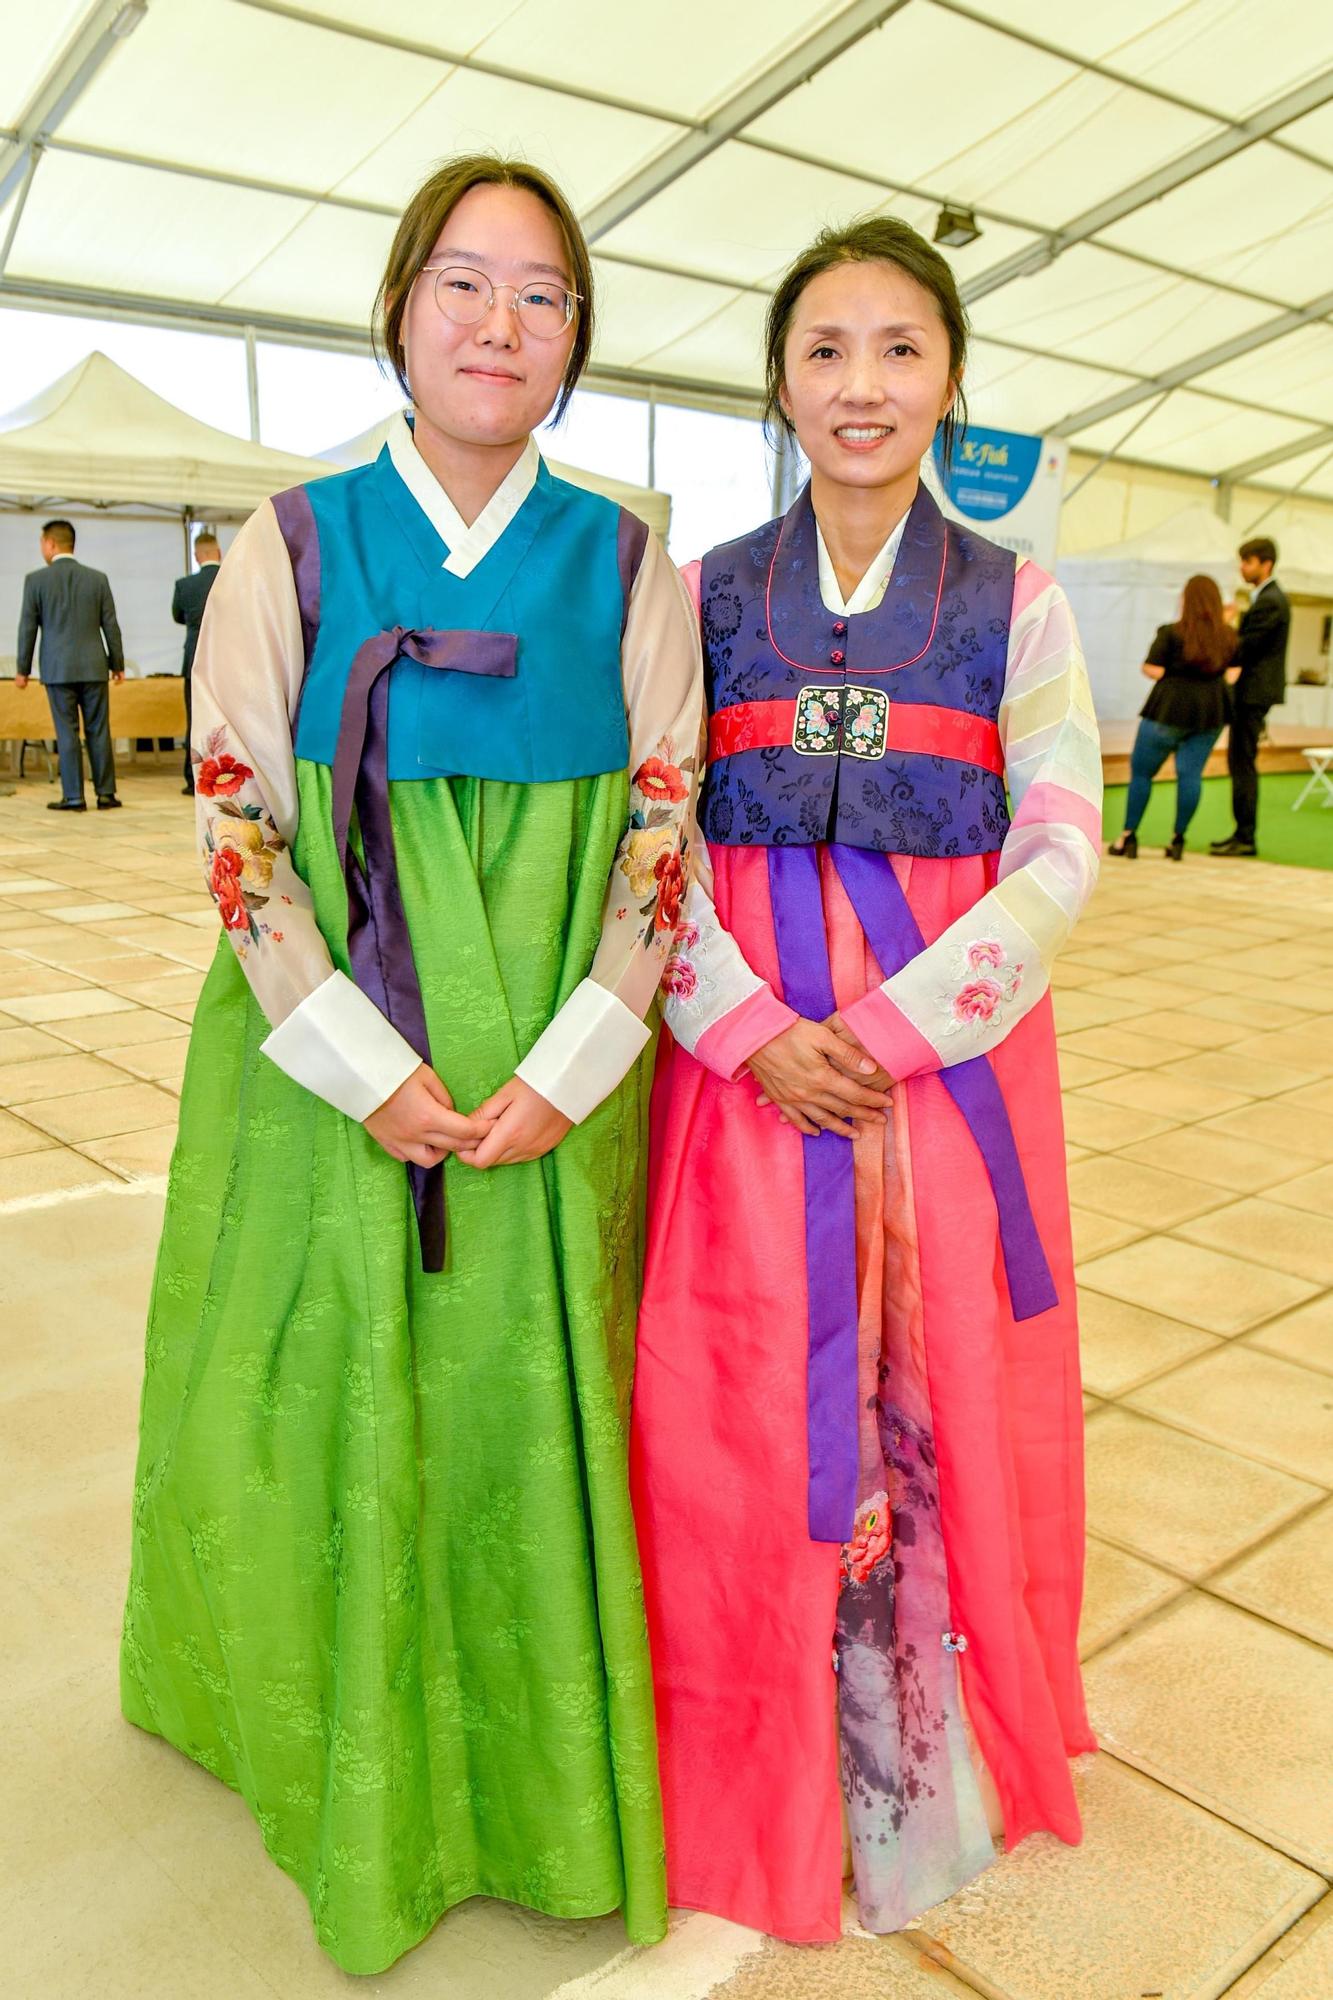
<box><xmin>1059</xmin><ymin>506</ymin><xmax>1333</xmax><ymax>722</ymax></box>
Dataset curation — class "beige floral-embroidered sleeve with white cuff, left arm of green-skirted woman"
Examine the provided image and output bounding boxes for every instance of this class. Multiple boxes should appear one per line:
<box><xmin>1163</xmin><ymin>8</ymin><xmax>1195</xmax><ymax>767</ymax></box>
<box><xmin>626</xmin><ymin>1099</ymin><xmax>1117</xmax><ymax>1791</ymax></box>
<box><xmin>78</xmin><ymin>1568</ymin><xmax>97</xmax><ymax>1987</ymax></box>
<box><xmin>190</xmin><ymin>502</ymin><xmax>420</xmax><ymax>1118</ymax></box>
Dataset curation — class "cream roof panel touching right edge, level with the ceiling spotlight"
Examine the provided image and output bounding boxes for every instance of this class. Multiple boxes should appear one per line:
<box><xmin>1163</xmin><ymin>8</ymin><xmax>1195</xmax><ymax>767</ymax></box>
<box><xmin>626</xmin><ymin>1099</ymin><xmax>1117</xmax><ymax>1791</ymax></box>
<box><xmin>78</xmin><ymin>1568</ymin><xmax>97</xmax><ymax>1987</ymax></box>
<box><xmin>1103</xmin><ymin>142</ymin><xmax>1333</xmax><ymax>306</ymax></box>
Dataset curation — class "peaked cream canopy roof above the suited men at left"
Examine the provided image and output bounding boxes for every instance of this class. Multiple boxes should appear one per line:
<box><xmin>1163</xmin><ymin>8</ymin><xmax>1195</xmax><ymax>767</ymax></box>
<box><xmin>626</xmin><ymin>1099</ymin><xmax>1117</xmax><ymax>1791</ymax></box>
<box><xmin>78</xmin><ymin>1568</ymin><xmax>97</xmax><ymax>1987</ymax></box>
<box><xmin>0</xmin><ymin>352</ymin><xmax>328</xmax><ymax>514</ymax></box>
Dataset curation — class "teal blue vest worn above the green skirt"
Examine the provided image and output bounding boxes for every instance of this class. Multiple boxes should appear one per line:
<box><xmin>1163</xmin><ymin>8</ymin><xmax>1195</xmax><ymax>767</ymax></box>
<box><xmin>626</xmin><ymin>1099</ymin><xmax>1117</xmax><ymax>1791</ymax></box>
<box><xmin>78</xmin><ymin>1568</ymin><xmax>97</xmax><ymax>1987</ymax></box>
<box><xmin>274</xmin><ymin>448</ymin><xmax>632</xmax><ymax>784</ymax></box>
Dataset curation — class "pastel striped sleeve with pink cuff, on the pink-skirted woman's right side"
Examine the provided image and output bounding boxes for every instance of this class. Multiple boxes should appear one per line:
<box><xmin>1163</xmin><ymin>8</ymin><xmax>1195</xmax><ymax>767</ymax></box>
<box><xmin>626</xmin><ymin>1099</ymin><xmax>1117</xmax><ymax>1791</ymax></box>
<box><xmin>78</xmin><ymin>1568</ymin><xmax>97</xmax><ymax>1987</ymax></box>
<box><xmin>843</xmin><ymin>562</ymin><xmax>1101</xmax><ymax>1078</ymax></box>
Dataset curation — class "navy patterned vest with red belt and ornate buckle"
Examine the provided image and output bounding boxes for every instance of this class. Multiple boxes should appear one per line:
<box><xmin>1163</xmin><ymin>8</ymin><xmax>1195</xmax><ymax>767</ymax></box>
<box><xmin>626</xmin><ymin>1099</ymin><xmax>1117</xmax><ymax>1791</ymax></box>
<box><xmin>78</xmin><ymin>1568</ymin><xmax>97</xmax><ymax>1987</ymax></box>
<box><xmin>701</xmin><ymin>486</ymin><xmax>1015</xmax><ymax>858</ymax></box>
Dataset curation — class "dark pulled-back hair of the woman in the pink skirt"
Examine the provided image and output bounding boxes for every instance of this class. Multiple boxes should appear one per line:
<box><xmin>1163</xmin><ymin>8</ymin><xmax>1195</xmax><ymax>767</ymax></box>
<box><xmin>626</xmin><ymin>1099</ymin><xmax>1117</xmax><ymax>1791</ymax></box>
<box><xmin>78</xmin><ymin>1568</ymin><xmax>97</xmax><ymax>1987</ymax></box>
<box><xmin>765</xmin><ymin>216</ymin><xmax>971</xmax><ymax>460</ymax></box>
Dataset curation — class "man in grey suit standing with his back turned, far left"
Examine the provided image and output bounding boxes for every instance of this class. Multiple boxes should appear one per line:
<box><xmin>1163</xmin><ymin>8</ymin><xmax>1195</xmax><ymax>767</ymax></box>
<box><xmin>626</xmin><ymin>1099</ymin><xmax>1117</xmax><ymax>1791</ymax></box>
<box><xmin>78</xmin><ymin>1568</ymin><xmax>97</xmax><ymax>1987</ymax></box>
<box><xmin>14</xmin><ymin>520</ymin><xmax>124</xmax><ymax>812</ymax></box>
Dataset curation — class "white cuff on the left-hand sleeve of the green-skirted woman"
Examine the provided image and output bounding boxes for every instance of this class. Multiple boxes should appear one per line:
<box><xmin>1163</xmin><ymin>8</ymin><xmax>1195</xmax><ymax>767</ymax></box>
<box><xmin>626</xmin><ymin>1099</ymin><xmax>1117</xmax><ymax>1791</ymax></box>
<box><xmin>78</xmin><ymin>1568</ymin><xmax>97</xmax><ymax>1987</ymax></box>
<box><xmin>262</xmin><ymin>972</ymin><xmax>420</xmax><ymax>1122</ymax></box>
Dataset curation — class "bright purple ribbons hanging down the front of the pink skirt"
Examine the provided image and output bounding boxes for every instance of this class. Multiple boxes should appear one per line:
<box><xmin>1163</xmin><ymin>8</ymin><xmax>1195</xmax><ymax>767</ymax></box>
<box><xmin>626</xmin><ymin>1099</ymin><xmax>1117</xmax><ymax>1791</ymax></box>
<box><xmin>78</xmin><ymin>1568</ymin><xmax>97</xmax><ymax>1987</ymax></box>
<box><xmin>769</xmin><ymin>842</ymin><xmax>1057</xmax><ymax>1542</ymax></box>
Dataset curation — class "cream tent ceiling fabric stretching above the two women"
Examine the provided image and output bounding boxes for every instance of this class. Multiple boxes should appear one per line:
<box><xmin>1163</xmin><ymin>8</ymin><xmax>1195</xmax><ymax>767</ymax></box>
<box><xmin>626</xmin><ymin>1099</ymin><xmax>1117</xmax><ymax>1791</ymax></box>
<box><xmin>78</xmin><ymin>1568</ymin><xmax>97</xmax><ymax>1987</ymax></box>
<box><xmin>0</xmin><ymin>0</ymin><xmax>1333</xmax><ymax>498</ymax></box>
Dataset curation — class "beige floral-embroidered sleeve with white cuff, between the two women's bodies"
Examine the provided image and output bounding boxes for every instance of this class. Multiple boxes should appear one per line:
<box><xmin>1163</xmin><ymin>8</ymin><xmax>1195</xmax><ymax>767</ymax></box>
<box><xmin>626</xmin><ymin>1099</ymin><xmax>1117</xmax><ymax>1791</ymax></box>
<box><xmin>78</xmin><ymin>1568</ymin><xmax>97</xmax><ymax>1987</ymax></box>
<box><xmin>518</xmin><ymin>536</ymin><xmax>705</xmax><ymax>1120</ymax></box>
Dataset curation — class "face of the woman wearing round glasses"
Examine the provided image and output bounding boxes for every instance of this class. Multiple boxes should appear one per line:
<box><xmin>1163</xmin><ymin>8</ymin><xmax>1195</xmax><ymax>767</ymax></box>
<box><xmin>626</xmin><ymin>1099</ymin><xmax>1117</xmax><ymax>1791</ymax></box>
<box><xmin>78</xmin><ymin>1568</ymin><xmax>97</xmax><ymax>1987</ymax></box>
<box><xmin>402</xmin><ymin>186</ymin><xmax>574</xmax><ymax>446</ymax></box>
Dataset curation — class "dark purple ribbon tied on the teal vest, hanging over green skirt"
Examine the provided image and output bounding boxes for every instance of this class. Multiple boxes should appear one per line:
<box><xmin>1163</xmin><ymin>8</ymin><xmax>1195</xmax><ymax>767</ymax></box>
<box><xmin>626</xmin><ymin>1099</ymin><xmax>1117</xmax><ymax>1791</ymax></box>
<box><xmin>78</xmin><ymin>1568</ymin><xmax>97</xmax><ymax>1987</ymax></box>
<box><xmin>332</xmin><ymin>626</ymin><xmax>518</xmax><ymax>1270</ymax></box>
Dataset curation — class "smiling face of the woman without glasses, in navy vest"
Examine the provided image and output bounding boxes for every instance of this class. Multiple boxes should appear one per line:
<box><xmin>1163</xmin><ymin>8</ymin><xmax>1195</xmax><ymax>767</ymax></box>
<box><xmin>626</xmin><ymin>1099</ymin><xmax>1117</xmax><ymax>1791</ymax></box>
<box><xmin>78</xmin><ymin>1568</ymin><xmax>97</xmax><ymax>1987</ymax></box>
<box><xmin>781</xmin><ymin>262</ymin><xmax>957</xmax><ymax>488</ymax></box>
